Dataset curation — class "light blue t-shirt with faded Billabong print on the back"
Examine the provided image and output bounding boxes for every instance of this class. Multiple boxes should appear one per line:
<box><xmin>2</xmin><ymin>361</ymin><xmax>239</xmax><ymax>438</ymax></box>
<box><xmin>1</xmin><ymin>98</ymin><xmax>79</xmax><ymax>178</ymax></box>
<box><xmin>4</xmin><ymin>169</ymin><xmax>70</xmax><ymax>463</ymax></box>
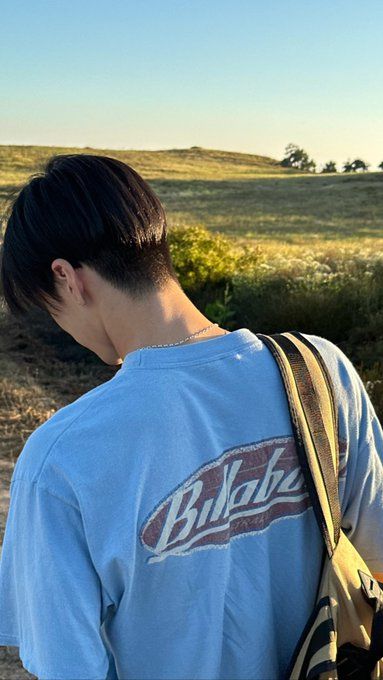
<box><xmin>0</xmin><ymin>328</ymin><xmax>383</xmax><ymax>680</ymax></box>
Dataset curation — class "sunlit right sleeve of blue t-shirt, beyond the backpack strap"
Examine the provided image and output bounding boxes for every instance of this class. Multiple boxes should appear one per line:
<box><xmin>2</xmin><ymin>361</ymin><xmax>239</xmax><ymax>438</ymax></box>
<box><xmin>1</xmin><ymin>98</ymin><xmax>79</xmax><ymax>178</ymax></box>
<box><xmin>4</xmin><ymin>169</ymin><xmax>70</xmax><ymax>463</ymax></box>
<box><xmin>304</xmin><ymin>334</ymin><xmax>383</xmax><ymax>573</ymax></box>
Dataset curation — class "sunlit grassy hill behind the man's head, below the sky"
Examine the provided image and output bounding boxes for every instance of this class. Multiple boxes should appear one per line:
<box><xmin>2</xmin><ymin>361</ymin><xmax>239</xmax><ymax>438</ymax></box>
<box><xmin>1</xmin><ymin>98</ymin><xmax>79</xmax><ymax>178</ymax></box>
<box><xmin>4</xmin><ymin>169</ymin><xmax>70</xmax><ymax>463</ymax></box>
<box><xmin>0</xmin><ymin>145</ymin><xmax>383</xmax><ymax>254</ymax></box>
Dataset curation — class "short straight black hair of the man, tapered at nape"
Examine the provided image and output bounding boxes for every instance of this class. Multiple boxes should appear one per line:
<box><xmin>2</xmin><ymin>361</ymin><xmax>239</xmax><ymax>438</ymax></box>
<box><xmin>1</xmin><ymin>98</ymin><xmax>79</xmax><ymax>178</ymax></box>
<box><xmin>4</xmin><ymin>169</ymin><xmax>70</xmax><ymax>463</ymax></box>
<box><xmin>0</xmin><ymin>153</ymin><xmax>179</xmax><ymax>315</ymax></box>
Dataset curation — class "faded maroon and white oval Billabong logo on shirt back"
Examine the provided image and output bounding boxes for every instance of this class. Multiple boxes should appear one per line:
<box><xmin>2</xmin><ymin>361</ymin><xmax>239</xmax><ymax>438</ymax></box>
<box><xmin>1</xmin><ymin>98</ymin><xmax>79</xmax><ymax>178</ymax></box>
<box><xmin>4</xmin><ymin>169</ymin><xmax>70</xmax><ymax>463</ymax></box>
<box><xmin>140</xmin><ymin>436</ymin><xmax>343</xmax><ymax>563</ymax></box>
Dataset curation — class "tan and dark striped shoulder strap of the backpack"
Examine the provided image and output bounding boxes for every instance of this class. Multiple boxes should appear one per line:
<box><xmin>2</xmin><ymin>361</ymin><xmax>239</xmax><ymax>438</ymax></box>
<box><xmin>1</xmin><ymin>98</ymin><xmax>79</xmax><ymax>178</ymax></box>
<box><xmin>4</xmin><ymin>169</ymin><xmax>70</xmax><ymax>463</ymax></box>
<box><xmin>257</xmin><ymin>331</ymin><xmax>341</xmax><ymax>557</ymax></box>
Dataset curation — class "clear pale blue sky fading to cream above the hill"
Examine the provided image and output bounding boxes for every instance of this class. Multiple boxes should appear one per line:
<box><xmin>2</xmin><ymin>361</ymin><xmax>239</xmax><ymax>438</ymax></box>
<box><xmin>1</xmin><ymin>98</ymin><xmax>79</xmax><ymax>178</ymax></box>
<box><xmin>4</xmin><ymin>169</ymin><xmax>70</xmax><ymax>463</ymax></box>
<box><xmin>0</xmin><ymin>0</ymin><xmax>383</xmax><ymax>169</ymax></box>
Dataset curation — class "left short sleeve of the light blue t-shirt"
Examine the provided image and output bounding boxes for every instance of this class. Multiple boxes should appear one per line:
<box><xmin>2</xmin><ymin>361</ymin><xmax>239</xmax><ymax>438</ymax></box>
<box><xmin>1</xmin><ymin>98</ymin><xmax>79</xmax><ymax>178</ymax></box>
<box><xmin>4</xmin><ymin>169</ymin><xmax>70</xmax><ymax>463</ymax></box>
<box><xmin>0</xmin><ymin>479</ymin><xmax>109</xmax><ymax>680</ymax></box>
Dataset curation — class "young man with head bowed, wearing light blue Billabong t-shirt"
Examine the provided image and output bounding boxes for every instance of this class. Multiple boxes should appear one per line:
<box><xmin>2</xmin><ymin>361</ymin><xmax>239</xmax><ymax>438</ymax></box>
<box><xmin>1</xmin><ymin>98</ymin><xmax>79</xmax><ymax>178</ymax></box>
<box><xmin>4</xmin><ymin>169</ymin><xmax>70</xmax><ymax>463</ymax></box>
<box><xmin>0</xmin><ymin>154</ymin><xmax>383</xmax><ymax>680</ymax></box>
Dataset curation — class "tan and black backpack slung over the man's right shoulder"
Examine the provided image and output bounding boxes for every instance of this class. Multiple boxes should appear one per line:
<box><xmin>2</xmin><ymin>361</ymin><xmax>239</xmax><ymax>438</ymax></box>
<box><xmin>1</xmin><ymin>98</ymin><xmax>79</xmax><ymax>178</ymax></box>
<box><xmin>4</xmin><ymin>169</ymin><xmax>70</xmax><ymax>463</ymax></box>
<box><xmin>257</xmin><ymin>331</ymin><xmax>383</xmax><ymax>680</ymax></box>
